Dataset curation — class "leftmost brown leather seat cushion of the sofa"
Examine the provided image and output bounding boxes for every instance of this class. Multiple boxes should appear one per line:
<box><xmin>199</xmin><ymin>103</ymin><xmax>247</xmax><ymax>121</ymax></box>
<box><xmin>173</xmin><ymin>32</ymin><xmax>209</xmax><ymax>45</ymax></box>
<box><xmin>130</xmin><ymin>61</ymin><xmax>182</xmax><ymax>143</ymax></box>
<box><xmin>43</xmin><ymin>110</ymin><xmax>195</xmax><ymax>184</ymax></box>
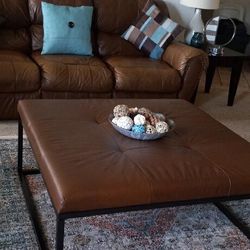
<box><xmin>0</xmin><ymin>50</ymin><xmax>40</xmax><ymax>93</ymax></box>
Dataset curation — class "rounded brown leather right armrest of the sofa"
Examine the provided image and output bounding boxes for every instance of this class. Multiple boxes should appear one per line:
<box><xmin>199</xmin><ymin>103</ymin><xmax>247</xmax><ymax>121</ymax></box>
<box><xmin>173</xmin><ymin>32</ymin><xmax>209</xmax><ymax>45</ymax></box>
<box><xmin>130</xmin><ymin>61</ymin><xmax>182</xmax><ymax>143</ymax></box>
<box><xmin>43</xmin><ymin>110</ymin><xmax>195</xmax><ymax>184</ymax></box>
<box><xmin>162</xmin><ymin>43</ymin><xmax>208</xmax><ymax>101</ymax></box>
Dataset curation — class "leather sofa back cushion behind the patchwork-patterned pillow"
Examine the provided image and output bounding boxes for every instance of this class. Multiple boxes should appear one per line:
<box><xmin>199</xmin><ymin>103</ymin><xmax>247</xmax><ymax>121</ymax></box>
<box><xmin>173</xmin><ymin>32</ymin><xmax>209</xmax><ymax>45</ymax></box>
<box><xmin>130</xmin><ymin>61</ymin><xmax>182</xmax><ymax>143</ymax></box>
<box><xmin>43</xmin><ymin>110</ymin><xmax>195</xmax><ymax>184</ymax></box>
<box><xmin>93</xmin><ymin>0</ymin><xmax>168</xmax><ymax>56</ymax></box>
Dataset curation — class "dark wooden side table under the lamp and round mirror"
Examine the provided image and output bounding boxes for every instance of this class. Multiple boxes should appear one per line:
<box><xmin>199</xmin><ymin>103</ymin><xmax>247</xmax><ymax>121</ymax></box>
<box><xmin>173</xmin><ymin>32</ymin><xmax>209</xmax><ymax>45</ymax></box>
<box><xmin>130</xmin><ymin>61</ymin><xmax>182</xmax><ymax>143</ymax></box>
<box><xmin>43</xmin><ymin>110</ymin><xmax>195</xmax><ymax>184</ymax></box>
<box><xmin>205</xmin><ymin>48</ymin><xmax>249</xmax><ymax>106</ymax></box>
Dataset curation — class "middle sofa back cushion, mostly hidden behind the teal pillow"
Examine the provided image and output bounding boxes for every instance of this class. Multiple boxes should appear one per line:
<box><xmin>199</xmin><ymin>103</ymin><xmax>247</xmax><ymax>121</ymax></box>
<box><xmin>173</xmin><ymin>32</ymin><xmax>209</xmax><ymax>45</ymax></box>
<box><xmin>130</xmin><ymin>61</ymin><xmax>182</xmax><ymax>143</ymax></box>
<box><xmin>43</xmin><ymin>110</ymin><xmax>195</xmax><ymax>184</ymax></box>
<box><xmin>27</xmin><ymin>0</ymin><xmax>92</xmax><ymax>50</ymax></box>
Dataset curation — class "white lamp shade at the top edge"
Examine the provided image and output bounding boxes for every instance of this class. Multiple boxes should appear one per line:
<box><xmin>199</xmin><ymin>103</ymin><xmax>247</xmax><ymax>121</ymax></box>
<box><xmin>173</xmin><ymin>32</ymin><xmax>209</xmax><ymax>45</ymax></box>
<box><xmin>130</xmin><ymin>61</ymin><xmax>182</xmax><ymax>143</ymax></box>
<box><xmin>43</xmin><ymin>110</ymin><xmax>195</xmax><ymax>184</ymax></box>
<box><xmin>180</xmin><ymin>0</ymin><xmax>220</xmax><ymax>10</ymax></box>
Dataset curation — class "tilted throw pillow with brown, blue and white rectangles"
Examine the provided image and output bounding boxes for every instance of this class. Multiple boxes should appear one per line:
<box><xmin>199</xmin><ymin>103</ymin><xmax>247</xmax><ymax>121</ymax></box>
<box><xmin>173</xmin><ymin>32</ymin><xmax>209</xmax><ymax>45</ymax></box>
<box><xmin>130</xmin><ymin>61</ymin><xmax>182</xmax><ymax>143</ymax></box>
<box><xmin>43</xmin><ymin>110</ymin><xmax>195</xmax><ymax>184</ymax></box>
<box><xmin>122</xmin><ymin>4</ymin><xmax>183</xmax><ymax>59</ymax></box>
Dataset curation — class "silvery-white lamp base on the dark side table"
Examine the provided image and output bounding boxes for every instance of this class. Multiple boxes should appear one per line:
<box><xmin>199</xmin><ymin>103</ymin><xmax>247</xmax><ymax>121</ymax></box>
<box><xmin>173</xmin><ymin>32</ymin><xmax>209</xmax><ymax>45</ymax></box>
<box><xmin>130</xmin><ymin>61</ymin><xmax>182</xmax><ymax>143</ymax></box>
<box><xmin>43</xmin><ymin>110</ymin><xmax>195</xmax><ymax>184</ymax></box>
<box><xmin>185</xmin><ymin>9</ymin><xmax>204</xmax><ymax>45</ymax></box>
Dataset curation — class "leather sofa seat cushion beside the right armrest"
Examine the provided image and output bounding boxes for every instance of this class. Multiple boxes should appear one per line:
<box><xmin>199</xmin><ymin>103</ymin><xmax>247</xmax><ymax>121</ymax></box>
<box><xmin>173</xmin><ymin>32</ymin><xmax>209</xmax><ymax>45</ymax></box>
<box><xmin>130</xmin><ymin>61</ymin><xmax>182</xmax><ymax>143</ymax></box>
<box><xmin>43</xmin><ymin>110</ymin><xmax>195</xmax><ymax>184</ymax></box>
<box><xmin>106</xmin><ymin>56</ymin><xmax>181</xmax><ymax>93</ymax></box>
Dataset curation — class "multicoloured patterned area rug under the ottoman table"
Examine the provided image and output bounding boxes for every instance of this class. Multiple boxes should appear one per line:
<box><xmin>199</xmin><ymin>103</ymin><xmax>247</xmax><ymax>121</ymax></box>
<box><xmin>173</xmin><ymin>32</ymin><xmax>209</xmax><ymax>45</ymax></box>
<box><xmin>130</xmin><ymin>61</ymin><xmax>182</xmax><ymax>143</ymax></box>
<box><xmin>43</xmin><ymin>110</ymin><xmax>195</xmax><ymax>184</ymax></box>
<box><xmin>0</xmin><ymin>140</ymin><xmax>250</xmax><ymax>250</ymax></box>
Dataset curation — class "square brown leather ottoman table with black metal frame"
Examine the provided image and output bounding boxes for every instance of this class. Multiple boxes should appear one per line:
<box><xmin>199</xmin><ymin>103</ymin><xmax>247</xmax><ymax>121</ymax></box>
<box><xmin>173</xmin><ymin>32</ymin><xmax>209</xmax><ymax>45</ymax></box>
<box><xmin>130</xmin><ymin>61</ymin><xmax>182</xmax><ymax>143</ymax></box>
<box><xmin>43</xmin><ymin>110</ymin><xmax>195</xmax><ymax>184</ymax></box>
<box><xmin>18</xmin><ymin>99</ymin><xmax>250</xmax><ymax>249</ymax></box>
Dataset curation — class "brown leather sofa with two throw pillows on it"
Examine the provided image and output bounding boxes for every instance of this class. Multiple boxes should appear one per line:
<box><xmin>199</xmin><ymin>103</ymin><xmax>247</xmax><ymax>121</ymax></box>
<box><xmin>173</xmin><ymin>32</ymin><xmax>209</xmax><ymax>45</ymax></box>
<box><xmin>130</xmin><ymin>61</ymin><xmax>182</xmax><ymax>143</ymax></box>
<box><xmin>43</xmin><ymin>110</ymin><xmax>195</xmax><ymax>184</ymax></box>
<box><xmin>0</xmin><ymin>0</ymin><xmax>207</xmax><ymax>119</ymax></box>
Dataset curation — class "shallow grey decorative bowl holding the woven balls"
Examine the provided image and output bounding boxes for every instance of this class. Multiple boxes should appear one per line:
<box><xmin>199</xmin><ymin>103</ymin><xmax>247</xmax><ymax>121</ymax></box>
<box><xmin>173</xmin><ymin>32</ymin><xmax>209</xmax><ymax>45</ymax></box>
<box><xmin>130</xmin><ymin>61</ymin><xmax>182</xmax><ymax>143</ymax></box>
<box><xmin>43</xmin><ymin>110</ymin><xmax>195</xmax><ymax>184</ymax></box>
<box><xmin>108</xmin><ymin>114</ymin><xmax>175</xmax><ymax>141</ymax></box>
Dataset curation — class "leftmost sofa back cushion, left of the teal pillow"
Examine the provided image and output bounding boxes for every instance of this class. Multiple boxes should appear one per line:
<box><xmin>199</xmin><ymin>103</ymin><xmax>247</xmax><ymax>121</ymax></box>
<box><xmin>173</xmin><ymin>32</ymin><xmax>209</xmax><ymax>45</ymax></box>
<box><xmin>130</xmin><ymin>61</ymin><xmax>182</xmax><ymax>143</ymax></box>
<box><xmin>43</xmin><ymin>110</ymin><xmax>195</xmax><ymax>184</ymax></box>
<box><xmin>0</xmin><ymin>0</ymin><xmax>30</xmax><ymax>52</ymax></box>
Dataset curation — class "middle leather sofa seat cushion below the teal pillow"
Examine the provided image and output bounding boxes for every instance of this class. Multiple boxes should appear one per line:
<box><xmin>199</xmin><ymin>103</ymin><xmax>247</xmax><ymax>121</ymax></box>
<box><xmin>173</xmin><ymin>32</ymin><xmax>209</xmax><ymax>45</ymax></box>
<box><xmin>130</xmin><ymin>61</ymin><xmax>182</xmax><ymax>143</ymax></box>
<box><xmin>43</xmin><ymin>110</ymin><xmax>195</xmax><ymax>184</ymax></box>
<box><xmin>32</xmin><ymin>52</ymin><xmax>113</xmax><ymax>92</ymax></box>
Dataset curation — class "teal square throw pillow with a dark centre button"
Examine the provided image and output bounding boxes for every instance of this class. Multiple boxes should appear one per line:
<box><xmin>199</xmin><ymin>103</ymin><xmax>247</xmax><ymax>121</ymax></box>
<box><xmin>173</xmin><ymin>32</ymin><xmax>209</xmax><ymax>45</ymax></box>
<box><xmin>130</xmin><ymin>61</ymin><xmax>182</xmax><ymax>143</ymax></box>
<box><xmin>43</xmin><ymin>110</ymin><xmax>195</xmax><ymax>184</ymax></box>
<box><xmin>42</xmin><ymin>2</ymin><xmax>93</xmax><ymax>56</ymax></box>
